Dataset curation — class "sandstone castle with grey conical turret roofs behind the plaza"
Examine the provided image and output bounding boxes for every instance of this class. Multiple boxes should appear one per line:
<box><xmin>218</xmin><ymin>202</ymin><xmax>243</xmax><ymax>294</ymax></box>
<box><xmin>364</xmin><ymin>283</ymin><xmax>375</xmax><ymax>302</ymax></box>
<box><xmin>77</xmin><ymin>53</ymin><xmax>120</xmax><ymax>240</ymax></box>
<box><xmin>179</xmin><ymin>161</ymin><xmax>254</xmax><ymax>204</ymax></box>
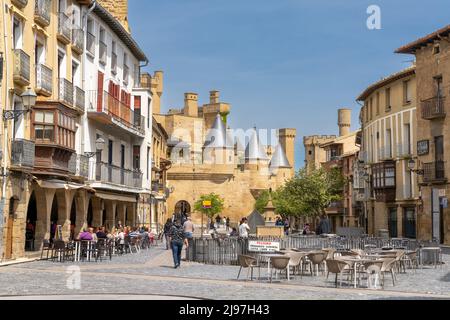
<box><xmin>143</xmin><ymin>72</ymin><xmax>296</xmax><ymax>223</ymax></box>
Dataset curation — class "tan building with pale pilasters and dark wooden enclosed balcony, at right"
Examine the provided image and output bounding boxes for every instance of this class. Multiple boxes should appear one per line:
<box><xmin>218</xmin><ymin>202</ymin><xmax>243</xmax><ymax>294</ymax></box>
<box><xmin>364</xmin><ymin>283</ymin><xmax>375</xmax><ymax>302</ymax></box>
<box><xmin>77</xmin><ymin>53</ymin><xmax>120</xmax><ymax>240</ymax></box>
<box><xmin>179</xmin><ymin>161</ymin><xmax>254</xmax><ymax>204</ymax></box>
<box><xmin>357</xmin><ymin>66</ymin><xmax>421</xmax><ymax>238</ymax></box>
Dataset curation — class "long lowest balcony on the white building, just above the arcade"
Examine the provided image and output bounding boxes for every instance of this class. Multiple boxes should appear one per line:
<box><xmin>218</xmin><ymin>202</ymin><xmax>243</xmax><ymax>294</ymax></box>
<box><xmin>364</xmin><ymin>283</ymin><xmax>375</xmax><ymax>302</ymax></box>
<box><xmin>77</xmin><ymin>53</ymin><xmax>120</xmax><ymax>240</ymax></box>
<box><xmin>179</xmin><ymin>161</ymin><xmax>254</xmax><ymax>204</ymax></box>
<box><xmin>92</xmin><ymin>162</ymin><xmax>142</xmax><ymax>188</ymax></box>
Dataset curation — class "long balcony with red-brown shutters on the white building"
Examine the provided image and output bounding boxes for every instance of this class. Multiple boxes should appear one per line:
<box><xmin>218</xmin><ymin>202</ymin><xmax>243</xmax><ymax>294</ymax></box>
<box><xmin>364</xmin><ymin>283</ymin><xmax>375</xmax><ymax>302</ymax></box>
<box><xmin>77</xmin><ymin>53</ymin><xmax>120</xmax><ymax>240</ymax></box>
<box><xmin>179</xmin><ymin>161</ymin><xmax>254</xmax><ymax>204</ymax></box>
<box><xmin>88</xmin><ymin>91</ymin><xmax>145</xmax><ymax>138</ymax></box>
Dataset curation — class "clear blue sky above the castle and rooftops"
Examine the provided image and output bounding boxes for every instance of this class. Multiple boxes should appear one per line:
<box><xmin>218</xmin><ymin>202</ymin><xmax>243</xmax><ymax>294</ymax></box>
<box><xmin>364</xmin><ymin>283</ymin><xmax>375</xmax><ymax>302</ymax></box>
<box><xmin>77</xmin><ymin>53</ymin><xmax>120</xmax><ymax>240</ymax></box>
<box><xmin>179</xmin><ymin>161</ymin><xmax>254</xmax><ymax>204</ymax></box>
<box><xmin>129</xmin><ymin>0</ymin><xmax>450</xmax><ymax>167</ymax></box>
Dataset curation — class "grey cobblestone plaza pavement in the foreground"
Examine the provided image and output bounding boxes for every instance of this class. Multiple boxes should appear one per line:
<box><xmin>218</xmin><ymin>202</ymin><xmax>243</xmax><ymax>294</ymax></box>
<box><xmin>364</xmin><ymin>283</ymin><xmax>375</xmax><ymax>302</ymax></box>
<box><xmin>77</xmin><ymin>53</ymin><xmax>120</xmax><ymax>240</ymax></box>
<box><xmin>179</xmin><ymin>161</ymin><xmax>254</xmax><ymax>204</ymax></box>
<box><xmin>0</xmin><ymin>247</ymin><xmax>450</xmax><ymax>300</ymax></box>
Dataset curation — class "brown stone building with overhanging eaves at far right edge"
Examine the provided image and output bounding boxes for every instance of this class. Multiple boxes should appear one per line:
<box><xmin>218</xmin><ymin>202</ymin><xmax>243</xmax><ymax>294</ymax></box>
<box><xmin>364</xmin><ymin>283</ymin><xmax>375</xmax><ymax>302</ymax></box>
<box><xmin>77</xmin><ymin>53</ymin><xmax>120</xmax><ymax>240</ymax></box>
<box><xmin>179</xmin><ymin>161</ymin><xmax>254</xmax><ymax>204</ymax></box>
<box><xmin>396</xmin><ymin>26</ymin><xmax>450</xmax><ymax>245</ymax></box>
